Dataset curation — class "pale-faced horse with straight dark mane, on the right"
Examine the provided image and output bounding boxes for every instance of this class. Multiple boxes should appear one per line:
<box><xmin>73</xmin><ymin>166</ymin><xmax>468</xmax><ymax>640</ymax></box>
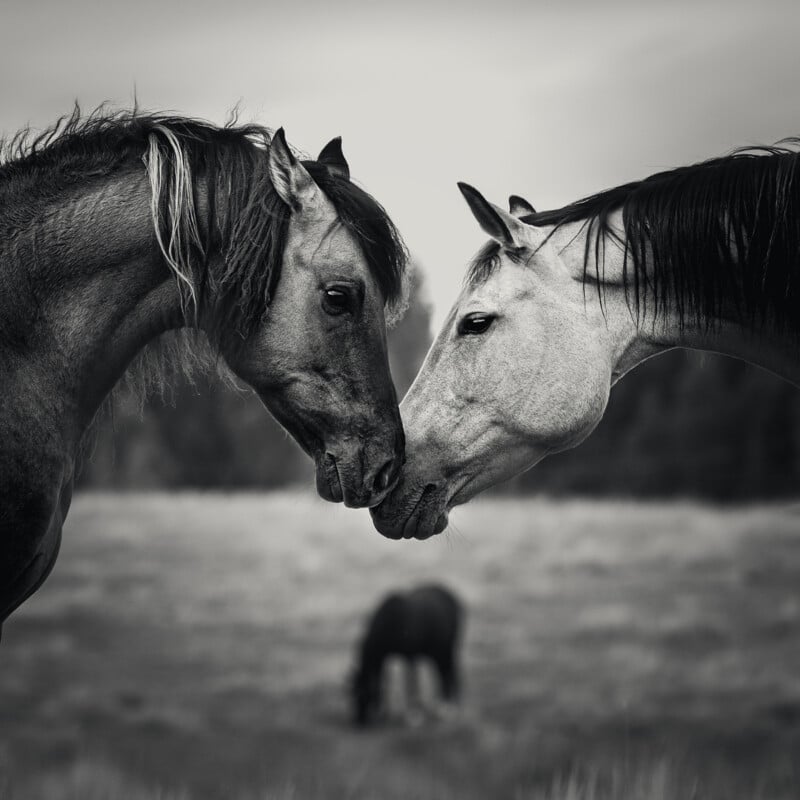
<box><xmin>373</xmin><ymin>140</ymin><xmax>800</xmax><ymax>538</ymax></box>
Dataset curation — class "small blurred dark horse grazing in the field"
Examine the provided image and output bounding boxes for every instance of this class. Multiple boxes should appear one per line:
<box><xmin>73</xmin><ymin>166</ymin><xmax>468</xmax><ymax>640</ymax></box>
<box><xmin>351</xmin><ymin>586</ymin><xmax>464</xmax><ymax>725</ymax></box>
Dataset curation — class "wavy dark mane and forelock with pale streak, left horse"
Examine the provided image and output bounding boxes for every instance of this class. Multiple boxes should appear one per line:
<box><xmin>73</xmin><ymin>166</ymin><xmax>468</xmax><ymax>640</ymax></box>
<box><xmin>0</xmin><ymin>107</ymin><xmax>407</xmax><ymax>337</ymax></box>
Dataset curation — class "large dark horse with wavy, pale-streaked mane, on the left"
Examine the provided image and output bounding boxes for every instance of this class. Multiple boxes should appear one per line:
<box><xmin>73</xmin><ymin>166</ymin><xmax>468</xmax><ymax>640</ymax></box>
<box><xmin>0</xmin><ymin>109</ymin><xmax>406</xmax><ymax>623</ymax></box>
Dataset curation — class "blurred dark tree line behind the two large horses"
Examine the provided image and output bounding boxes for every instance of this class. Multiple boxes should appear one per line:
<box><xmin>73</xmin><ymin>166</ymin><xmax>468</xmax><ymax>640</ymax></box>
<box><xmin>76</xmin><ymin>269</ymin><xmax>800</xmax><ymax>499</ymax></box>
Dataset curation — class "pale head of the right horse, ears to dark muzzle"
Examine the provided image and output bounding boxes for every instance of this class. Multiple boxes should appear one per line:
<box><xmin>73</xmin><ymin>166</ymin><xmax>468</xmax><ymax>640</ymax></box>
<box><xmin>373</xmin><ymin>184</ymin><xmax>614</xmax><ymax>539</ymax></box>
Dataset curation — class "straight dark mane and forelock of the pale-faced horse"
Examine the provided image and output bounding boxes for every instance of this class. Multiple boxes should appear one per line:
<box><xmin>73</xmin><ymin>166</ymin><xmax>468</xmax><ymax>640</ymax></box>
<box><xmin>467</xmin><ymin>138</ymin><xmax>800</xmax><ymax>336</ymax></box>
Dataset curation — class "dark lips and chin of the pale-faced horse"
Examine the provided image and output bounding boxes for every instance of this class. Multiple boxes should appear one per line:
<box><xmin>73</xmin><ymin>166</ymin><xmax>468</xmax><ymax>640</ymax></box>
<box><xmin>370</xmin><ymin>484</ymin><xmax>448</xmax><ymax>539</ymax></box>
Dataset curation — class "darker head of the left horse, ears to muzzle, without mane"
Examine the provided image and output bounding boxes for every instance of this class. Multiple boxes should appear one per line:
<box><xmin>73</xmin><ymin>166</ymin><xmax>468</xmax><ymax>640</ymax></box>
<box><xmin>209</xmin><ymin>131</ymin><xmax>405</xmax><ymax>507</ymax></box>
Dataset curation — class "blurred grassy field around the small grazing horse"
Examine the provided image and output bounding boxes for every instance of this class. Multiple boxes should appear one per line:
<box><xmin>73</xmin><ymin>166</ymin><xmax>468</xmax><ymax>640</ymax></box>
<box><xmin>0</xmin><ymin>493</ymin><xmax>800</xmax><ymax>800</ymax></box>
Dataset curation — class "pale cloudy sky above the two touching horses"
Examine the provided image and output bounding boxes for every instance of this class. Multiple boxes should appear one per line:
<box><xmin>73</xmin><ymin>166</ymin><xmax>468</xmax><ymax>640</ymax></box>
<box><xmin>0</xmin><ymin>0</ymin><xmax>800</xmax><ymax>324</ymax></box>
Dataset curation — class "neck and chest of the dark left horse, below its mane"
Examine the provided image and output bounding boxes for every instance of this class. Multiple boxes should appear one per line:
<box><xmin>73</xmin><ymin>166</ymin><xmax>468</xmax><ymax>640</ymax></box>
<box><xmin>0</xmin><ymin>166</ymin><xmax>182</xmax><ymax>622</ymax></box>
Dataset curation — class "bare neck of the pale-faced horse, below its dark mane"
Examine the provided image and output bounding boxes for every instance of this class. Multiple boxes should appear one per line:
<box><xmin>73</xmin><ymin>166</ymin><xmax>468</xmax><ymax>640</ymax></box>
<box><xmin>551</xmin><ymin>214</ymin><xmax>800</xmax><ymax>386</ymax></box>
